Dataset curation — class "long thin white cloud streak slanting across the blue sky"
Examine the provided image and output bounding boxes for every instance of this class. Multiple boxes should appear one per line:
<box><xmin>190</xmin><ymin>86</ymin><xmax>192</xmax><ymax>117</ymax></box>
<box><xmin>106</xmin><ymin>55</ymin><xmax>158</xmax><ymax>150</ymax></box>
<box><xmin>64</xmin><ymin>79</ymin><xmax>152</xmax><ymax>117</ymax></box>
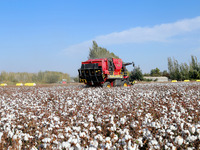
<box><xmin>65</xmin><ymin>16</ymin><xmax>200</xmax><ymax>54</ymax></box>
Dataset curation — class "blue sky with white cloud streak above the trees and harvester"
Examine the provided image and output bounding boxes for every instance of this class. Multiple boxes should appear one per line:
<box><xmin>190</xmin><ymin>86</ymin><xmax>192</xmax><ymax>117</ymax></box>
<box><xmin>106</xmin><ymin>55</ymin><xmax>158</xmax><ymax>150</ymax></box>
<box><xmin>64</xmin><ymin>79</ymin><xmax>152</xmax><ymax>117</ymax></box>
<box><xmin>0</xmin><ymin>0</ymin><xmax>200</xmax><ymax>76</ymax></box>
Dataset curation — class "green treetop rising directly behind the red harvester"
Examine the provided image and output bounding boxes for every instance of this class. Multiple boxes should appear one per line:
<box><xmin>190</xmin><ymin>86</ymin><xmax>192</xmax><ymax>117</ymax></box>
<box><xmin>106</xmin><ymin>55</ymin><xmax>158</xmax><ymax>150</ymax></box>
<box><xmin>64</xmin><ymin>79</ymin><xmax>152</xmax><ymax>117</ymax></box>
<box><xmin>88</xmin><ymin>41</ymin><xmax>119</xmax><ymax>59</ymax></box>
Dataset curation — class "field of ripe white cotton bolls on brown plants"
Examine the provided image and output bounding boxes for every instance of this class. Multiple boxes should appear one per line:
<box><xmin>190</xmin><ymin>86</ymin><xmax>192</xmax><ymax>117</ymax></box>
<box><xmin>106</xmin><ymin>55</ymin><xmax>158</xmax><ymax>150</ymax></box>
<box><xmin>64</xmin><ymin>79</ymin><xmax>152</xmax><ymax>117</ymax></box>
<box><xmin>0</xmin><ymin>82</ymin><xmax>200</xmax><ymax>150</ymax></box>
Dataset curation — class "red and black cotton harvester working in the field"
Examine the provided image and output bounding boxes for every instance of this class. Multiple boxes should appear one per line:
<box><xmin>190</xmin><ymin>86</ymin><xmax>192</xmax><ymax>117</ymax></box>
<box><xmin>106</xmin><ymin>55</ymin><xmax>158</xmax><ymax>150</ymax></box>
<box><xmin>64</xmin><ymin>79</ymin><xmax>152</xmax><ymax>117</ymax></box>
<box><xmin>78</xmin><ymin>58</ymin><xmax>134</xmax><ymax>87</ymax></box>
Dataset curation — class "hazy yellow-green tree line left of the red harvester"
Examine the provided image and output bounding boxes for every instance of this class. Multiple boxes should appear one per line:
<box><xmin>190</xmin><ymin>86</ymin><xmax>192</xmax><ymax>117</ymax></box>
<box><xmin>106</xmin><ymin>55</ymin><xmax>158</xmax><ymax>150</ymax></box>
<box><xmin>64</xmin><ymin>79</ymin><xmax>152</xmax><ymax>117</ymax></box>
<box><xmin>0</xmin><ymin>71</ymin><xmax>70</xmax><ymax>83</ymax></box>
